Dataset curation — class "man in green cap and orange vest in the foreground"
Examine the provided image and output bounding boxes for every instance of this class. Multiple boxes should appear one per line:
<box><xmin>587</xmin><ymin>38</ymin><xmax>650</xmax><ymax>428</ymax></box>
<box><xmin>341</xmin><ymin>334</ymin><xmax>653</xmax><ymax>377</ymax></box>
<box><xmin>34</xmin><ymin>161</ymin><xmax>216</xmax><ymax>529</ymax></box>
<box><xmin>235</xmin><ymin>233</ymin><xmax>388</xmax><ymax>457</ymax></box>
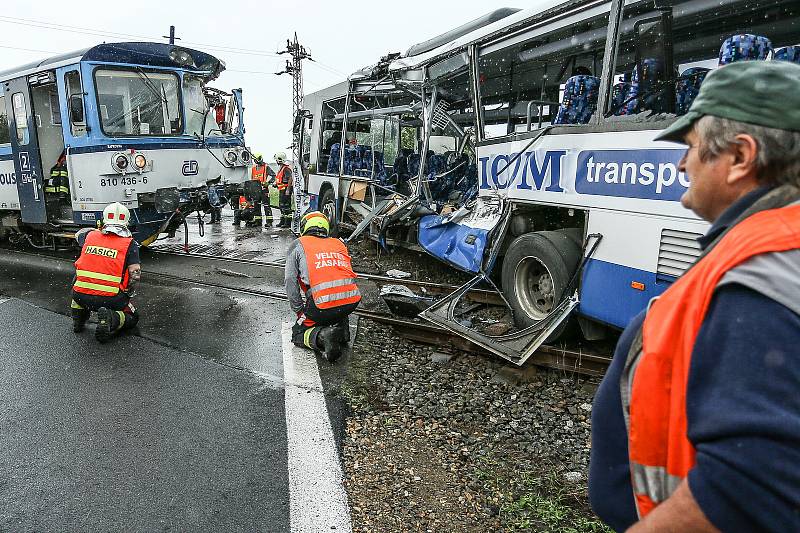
<box><xmin>589</xmin><ymin>61</ymin><xmax>800</xmax><ymax>532</ymax></box>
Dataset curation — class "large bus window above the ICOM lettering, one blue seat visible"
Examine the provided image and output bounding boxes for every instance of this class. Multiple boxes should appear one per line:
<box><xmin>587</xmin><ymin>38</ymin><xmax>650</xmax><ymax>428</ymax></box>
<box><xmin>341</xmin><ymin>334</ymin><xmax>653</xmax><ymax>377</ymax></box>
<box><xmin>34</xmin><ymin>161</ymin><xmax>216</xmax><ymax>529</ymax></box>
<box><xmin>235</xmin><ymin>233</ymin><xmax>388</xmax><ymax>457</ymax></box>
<box><xmin>478</xmin><ymin>12</ymin><xmax>608</xmax><ymax>139</ymax></box>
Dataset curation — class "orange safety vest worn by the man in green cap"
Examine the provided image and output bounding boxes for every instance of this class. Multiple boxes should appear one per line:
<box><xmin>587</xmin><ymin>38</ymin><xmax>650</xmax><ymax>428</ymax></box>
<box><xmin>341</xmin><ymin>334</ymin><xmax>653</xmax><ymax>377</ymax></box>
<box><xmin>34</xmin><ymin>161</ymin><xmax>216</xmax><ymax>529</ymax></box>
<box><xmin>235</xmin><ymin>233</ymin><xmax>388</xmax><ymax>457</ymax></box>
<box><xmin>621</xmin><ymin>205</ymin><xmax>800</xmax><ymax>517</ymax></box>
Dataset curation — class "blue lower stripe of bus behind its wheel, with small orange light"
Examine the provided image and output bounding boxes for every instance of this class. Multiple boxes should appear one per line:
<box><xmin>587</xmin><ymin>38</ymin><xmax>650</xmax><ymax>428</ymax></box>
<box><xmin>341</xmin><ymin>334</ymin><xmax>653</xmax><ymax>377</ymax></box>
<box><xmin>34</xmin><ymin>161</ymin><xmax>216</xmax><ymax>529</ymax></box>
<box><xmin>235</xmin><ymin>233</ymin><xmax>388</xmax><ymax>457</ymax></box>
<box><xmin>578</xmin><ymin>259</ymin><xmax>674</xmax><ymax>328</ymax></box>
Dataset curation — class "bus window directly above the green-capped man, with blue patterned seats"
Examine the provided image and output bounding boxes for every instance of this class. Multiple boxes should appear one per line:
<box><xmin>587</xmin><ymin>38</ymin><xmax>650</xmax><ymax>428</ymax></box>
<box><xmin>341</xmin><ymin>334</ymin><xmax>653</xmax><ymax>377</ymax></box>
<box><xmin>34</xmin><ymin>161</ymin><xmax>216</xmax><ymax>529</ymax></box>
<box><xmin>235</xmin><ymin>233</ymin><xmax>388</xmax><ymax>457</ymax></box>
<box><xmin>606</xmin><ymin>0</ymin><xmax>800</xmax><ymax>118</ymax></box>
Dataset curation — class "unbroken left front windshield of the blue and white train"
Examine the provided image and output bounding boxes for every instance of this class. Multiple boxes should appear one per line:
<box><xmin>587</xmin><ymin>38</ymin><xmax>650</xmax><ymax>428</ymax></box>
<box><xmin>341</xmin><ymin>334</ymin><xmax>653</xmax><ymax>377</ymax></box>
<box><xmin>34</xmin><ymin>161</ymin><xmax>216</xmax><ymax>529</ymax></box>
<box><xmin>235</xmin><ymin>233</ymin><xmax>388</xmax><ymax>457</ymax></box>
<box><xmin>94</xmin><ymin>69</ymin><xmax>183</xmax><ymax>136</ymax></box>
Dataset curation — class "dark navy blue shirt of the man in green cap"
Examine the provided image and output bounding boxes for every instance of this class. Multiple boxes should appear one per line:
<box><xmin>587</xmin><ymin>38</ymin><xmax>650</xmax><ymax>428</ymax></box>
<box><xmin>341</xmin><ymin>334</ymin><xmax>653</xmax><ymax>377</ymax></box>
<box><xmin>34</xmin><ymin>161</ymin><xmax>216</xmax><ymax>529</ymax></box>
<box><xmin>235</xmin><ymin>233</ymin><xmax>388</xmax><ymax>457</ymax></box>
<box><xmin>589</xmin><ymin>188</ymin><xmax>800</xmax><ymax>532</ymax></box>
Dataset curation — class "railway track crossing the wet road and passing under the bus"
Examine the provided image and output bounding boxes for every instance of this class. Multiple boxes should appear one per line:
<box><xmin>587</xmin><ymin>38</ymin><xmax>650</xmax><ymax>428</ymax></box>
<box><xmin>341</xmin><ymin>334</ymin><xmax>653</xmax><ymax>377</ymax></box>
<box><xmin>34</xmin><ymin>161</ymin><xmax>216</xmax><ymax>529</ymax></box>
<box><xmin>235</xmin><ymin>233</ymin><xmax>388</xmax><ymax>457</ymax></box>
<box><xmin>2</xmin><ymin>248</ymin><xmax>611</xmax><ymax>376</ymax></box>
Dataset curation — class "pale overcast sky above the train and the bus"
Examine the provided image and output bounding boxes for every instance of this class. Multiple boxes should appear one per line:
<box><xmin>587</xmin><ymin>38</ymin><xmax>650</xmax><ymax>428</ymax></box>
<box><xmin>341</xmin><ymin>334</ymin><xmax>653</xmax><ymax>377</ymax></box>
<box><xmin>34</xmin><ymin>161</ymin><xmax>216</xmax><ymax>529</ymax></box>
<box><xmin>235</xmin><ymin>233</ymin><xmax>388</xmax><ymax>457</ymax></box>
<box><xmin>0</xmin><ymin>0</ymin><xmax>537</xmax><ymax>159</ymax></box>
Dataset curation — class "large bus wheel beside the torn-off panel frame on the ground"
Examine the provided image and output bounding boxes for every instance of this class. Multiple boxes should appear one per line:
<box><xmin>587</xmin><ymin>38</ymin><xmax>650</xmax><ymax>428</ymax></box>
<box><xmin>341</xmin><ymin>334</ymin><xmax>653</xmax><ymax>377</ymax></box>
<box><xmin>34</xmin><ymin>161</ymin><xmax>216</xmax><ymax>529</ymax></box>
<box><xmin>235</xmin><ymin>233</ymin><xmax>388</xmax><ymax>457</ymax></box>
<box><xmin>502</xmin><ymin>231</ymin><xmax>581</xmax><ymax>342</ymax></box>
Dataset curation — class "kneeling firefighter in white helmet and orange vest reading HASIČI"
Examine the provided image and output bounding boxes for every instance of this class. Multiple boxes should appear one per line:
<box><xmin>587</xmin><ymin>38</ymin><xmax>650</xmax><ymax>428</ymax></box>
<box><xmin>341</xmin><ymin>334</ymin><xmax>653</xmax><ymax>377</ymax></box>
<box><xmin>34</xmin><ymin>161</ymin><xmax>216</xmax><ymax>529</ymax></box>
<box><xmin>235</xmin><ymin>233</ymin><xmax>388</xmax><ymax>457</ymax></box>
<box><xmin>72</xmin><ymin>202</ymin><xmax>142</xmax><ymax>342</ymax></box>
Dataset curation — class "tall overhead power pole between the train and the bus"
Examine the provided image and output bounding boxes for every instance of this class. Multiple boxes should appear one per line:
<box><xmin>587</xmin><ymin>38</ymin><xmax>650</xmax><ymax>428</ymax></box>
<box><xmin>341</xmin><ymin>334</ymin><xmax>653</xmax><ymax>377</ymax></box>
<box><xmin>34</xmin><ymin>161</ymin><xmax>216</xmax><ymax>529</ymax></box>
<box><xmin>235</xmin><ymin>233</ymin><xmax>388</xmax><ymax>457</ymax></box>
<box><xmin>276</xmin><ymin>32</ymin><xmax>313</xmax><ymax>233</ymax></box>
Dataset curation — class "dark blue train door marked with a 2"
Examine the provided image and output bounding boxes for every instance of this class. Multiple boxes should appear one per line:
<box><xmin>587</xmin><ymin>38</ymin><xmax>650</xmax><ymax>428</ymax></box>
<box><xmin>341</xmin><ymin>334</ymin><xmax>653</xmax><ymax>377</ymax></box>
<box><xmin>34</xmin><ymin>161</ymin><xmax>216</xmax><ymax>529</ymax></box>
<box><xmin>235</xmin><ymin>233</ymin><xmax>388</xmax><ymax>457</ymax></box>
<box><xmin>4</xmin><ymin>77</ymin><xmax>47</xmax><ymax>224</ymax></box>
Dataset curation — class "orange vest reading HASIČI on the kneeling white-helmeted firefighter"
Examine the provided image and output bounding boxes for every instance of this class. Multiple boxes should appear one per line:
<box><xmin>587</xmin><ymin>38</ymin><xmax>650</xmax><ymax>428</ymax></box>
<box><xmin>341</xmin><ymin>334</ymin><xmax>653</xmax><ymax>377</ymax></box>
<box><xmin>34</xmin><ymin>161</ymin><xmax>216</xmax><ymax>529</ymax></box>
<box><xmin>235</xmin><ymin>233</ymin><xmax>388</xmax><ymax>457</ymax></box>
<box><xmin>72</xmin><ymin>230</ymin><xmax>133</xmax><ymax>296</ymax></box>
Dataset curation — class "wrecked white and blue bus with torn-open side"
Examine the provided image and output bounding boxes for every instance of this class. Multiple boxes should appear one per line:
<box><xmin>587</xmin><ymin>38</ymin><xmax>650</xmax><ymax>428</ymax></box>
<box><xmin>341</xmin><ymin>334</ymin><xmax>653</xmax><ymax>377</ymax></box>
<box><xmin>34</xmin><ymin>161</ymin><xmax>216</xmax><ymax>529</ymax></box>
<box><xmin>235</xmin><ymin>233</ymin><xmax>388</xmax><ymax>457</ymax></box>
<box><xmin>304</xmin><ymin>0</ymin><xmax>800</xmax><ymax>364</ymax></box>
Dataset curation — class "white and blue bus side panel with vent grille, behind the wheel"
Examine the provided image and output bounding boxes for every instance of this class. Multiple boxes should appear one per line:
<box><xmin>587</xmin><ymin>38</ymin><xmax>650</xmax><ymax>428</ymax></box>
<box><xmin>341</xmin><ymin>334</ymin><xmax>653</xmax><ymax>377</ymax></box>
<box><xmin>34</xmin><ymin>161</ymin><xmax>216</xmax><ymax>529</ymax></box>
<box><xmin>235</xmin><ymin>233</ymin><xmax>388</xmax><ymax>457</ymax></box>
<box><xmin>578</xmin><ymin>210</ymin><xmax>707</xmax><ymax>328</ymax></box>
